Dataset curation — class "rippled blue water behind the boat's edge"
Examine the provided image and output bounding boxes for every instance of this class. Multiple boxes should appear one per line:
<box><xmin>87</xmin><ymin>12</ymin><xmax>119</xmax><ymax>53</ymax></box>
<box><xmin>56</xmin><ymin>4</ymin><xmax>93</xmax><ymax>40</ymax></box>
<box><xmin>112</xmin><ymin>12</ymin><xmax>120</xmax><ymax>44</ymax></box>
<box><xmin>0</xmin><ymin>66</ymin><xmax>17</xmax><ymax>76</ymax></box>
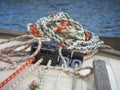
<box><xmin>0</xmin><ymin>0</ymin><xmax>120</xmax><ymax>37</ymax></box>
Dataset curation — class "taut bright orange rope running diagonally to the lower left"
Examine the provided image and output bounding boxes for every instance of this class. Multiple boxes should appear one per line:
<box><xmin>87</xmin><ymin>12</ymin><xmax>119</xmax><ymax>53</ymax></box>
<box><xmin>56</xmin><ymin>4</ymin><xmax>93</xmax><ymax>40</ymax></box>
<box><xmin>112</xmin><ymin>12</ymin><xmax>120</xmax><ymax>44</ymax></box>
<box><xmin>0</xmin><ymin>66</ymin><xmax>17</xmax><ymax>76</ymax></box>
<box><xmin>0</xmin><ymin>57</ymin><xmax>35</xmax><ymax>88</ymax></box>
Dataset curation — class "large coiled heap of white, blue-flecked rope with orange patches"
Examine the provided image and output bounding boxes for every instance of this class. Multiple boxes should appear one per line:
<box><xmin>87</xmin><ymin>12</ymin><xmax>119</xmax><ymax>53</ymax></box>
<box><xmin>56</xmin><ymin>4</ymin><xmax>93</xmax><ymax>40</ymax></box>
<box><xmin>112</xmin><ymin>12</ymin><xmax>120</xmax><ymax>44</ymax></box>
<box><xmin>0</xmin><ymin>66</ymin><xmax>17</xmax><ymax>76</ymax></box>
<box><xmin>27</xmin><ymin>12</ymin><xmax>110</xmax><ymax>54</ymax></box>
